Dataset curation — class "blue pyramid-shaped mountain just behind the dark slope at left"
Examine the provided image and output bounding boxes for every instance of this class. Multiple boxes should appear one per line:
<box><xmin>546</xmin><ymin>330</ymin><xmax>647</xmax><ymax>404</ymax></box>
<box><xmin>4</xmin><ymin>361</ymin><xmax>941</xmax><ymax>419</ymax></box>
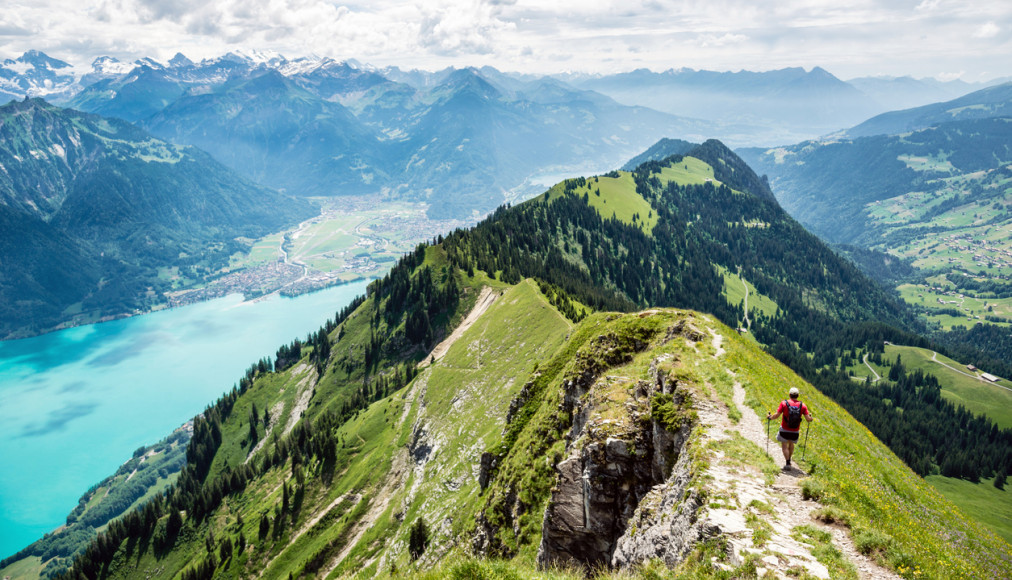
<box><xmin>142</xmin><ymin>71</ymin><xmax>389</xmax><ymax>195</ymax></box>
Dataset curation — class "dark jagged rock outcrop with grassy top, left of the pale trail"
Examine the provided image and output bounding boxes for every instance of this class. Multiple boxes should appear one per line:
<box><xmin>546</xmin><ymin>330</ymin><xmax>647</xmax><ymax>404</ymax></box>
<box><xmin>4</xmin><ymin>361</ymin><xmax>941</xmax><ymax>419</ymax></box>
<box><xmin>537</xmin><ymin>357</ymin><xmax>692</xmax><ymax>569</ymax></box>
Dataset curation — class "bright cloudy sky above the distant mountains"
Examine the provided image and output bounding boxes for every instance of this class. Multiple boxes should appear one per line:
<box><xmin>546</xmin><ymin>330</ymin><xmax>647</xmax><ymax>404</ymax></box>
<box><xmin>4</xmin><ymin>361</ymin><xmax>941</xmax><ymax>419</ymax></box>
<box><xmin>0</xmin><ymin>0</ymin><xmax>1012</xmax><ymax>81</ymax></box>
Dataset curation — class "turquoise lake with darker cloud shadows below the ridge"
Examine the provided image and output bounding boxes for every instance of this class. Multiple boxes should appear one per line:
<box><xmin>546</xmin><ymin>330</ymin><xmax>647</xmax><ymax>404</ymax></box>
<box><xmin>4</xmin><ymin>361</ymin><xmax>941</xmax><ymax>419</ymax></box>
<box><xmin>0</xmin><ymin>281</ymin><xmax>366</xmax><ymax>558</ymax></box>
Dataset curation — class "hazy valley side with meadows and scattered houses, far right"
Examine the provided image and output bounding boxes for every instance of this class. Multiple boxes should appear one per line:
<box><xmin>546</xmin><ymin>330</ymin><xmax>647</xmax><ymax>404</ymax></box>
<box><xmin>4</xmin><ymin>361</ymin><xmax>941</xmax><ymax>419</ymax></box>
<box><xmin>740</xmin><ymin>114</ymin><xmax>1012</xmax><ymax>384</ymax></box>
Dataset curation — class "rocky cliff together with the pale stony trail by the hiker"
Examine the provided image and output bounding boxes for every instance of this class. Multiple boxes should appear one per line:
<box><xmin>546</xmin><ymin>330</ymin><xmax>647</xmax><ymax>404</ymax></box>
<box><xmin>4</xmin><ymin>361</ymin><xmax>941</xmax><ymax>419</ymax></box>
<box><xmin>537</xmin><ymin>311</ymin><xmax>898</xmax><ymax>578</ymax></box>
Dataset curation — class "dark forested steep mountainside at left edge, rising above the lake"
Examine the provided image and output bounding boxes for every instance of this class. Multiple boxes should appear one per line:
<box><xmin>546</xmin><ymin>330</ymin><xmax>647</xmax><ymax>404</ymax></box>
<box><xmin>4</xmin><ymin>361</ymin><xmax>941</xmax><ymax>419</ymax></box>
<box><xmin>0</xmin><ymin>99</ymin><xmax>313</xmax><ymax>337</ymax></box>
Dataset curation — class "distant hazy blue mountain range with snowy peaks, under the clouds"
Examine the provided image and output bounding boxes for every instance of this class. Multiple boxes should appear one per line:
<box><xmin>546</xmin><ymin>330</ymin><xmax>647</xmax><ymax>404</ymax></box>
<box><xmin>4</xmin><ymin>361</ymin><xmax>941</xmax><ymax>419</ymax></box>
<box><xmin>4</xmin><ymin>47</ymin><xmax>995</xmax><ymax>218</ymax></box>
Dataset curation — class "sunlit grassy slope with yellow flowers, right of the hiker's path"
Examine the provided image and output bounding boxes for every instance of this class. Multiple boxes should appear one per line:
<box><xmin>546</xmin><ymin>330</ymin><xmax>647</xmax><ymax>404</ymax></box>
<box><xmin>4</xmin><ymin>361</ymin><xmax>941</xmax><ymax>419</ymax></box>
<box><xmin>726</xmin><ymin>325</ymin><xmax>1012</xmax><ymax>578</ymax></box>
